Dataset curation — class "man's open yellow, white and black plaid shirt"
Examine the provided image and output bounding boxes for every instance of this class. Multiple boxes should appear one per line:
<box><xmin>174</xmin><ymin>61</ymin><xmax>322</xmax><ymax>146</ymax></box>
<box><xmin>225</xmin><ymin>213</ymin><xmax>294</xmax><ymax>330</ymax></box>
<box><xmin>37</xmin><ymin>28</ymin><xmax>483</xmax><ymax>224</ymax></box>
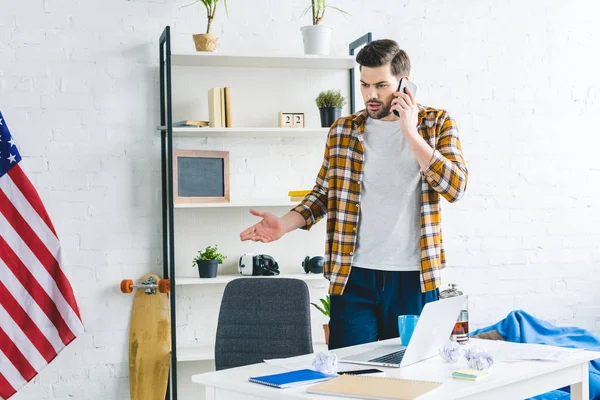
<box><xmin>292</xmin><ymin>105</ymin><xmax>468</xmax><ymax>295</ymax></box>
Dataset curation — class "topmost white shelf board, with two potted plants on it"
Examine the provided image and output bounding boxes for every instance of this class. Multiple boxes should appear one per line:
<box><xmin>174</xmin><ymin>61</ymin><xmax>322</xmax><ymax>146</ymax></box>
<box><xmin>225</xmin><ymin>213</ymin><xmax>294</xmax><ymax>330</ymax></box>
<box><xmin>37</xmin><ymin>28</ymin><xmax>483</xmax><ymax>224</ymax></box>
<box><xmin>171</xmin><ymin>52</ymin><xmax>356</xmax><ymax>69</ymax></box>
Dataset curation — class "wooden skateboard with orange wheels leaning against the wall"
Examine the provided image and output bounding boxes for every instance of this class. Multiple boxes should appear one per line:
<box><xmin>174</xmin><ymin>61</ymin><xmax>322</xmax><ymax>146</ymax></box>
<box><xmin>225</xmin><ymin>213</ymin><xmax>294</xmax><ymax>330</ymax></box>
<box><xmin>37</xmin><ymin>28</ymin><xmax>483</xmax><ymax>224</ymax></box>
<box><xmin>121</xmin><ymin>274</ymin><xmax>171</xmax><ymax>400</ymax></box>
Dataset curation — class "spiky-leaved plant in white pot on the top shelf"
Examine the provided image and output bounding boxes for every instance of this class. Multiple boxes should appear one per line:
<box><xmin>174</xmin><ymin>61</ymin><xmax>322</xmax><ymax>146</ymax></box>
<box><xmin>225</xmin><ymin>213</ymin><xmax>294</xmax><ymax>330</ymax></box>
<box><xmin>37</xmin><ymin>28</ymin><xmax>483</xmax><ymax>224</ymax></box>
<box><xmin>300</xmin><ymin>0</ymin><xmax>349</xmax><ymax>55</ymax></box>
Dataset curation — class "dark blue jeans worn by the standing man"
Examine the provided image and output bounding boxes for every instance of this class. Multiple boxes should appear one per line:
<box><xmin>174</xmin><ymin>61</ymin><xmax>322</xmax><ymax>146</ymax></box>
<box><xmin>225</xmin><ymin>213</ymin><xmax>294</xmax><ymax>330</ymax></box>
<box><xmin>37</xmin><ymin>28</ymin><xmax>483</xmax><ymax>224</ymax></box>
<box><xmin>329</xmin><ymin>267</ymin><xmax>439</xmax><ymax>350</ymax></box>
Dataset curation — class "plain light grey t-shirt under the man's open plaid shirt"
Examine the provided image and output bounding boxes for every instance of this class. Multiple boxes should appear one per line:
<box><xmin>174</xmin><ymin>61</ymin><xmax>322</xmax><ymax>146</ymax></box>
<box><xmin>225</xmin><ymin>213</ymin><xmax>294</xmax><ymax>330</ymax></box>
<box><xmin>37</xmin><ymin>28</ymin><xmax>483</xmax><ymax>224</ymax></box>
<box><xmin>352</xmin><ymin>118</ymin><xmax>421</xmax><ymax>271</ymax></box>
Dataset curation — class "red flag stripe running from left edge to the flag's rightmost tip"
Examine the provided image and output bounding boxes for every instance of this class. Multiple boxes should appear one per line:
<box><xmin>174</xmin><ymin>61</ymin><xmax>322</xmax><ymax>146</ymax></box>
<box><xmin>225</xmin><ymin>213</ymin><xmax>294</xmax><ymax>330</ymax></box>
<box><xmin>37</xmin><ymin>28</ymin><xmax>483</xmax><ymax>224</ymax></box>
<box><xmin>0</xmin><ymin>190</ymin><xmax>80</xmax><ymax>318</ymax></box>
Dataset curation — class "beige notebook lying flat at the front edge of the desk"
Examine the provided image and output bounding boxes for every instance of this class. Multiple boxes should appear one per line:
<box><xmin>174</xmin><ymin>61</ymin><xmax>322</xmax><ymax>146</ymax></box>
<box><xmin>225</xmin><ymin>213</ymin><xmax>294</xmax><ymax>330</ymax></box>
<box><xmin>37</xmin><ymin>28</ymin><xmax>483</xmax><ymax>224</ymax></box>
<box><xmin>306</xmin><ymin>375</ymin><xmax>442</xmax><ymax>400</ymax></box>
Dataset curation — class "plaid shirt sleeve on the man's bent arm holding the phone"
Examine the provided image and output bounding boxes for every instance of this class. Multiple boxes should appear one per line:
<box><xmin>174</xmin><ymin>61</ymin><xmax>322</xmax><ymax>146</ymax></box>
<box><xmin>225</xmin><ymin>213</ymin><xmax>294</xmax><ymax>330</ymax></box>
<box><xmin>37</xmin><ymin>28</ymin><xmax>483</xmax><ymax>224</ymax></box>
<box><xmin>423</xmin><ymin>113</ymin><xmax>469</xmax><ymax>203</ymax></box>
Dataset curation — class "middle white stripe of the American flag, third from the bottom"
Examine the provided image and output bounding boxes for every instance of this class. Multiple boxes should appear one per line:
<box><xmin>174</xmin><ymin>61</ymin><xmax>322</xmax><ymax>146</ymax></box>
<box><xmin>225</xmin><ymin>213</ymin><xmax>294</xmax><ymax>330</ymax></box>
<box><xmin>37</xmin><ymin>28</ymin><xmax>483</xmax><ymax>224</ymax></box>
<box><xmin>0</xmin><ymin>257</ymin><xmax>66</xmax><ymax>352</ymax></box>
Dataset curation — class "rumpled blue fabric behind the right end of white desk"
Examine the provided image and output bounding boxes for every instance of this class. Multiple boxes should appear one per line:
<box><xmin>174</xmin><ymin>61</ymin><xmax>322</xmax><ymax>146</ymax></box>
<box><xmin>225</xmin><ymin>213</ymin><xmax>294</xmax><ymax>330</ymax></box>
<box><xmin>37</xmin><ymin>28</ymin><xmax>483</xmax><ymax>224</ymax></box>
<box><xmin>470</xmin><ymin>310</ymin><xmax>600</xmax><ymax>400</ymax></box>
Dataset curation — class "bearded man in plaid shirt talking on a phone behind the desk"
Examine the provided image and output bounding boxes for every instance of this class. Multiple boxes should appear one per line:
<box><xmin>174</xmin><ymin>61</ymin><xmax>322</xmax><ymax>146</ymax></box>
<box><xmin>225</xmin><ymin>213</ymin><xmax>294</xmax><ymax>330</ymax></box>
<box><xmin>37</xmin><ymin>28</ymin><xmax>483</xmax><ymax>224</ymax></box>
<box><xmin>240</xmin><ymin>40</ymin><xmax>468</xmax><ymax>349</ymax></box>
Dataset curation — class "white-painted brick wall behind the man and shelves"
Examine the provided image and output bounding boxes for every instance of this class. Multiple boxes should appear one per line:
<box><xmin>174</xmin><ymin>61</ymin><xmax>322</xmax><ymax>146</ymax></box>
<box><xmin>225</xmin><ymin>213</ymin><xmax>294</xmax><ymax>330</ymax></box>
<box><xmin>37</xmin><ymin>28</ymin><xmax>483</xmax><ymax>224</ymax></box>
<box><xmin>0</xmin><ymin>0</ymin><xmax>600</xmax><ymax>400</ymax></box>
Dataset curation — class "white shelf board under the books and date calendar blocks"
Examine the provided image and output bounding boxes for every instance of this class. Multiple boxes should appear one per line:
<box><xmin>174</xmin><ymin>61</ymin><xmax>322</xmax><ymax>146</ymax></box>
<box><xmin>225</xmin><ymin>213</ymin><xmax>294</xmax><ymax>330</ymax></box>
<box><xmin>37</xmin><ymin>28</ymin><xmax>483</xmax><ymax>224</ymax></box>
<box><xmin>157</xmin><ymin>126</ymin><xmax>329</xmax><ymax>138</ymax></box>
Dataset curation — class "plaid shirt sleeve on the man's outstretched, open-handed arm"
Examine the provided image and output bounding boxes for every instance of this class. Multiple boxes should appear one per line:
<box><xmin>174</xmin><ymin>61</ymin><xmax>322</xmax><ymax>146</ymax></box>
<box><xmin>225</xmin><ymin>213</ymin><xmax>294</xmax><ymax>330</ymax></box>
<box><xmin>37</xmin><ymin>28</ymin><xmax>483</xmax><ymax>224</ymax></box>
<box><xmin>292</xmin><ymin>135</ymin><xmax>330</xmax><ymax>231</ymax></box>
